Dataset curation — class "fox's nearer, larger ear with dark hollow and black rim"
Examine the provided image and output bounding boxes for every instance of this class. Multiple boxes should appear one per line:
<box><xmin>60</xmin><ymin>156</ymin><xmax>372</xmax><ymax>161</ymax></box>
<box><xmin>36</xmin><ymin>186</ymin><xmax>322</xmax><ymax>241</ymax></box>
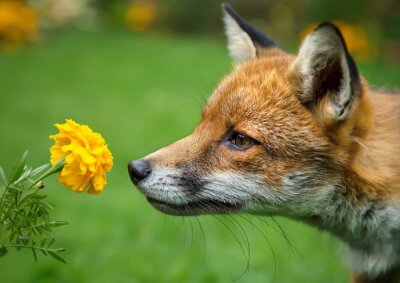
<box><xmin>295</xmin><ymin>22</ymin><xmax>361</xmax><ymax>121</ymax></box>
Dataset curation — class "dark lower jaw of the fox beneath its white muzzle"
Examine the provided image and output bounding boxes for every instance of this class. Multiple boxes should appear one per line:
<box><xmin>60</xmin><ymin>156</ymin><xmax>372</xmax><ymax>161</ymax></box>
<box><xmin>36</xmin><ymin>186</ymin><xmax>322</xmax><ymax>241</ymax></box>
<box><xmin>146</xmin><ymin>197</ymin><xmax>242</xmax><ymax>216</ymax></box>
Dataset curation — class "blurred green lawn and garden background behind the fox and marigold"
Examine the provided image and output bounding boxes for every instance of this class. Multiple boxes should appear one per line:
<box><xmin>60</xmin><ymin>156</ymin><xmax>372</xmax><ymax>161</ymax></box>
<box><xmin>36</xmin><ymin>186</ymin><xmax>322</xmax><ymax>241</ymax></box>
<box><xmin>0</xmin><ymin>0</ymin><xmax>400</xmax><ymax>282</ymax></box>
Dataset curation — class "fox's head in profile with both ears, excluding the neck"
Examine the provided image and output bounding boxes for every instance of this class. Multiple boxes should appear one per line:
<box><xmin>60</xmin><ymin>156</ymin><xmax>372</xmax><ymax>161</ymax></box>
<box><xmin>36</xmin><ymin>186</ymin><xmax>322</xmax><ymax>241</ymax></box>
<box><xmin>128</xmin><ymin>4</ymin><xmax>370</xmax><ymax>218</ymax></box>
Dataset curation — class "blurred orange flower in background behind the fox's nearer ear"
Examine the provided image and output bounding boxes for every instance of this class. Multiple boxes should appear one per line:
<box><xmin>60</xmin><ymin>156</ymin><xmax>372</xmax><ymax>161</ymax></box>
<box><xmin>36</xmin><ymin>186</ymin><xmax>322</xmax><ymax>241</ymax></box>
<box><xmin>299</xmin><ymin>20</ymin><xmax>378</xmax><ymax>62</ymax></box>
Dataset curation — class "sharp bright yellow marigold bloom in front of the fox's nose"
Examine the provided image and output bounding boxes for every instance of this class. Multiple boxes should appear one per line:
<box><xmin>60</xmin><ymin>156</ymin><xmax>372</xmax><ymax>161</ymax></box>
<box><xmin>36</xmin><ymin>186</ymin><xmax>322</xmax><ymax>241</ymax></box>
<box><xmin>50</xmin><ymin>119</ymin><xmax>113</xmax><ymax>194</ymax></box>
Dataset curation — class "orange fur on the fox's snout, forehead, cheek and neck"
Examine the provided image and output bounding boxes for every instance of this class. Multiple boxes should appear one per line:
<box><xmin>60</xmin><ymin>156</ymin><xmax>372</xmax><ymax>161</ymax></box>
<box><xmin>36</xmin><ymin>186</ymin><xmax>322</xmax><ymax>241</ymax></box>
<box><xmin>150</xmin><ymin>52</ymin><xmax>400</xmax><ymax>202</ymax></box>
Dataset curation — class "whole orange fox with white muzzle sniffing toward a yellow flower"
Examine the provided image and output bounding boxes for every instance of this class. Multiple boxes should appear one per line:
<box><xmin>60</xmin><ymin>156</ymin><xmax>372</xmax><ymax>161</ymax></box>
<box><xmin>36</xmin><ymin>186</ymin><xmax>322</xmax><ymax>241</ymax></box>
<box><xmin>128</xmin><ymin>3</ymin><xmax>400</xmax><ymax>283</ymax></box>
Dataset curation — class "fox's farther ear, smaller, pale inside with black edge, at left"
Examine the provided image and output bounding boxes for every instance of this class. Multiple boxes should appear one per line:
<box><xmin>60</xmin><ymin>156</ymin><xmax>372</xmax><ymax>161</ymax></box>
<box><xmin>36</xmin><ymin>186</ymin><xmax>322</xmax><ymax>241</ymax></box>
<box><xmin>222</xmin><ymin>3</ymin><xmax>277</xmax><ymax>63</ymax></box>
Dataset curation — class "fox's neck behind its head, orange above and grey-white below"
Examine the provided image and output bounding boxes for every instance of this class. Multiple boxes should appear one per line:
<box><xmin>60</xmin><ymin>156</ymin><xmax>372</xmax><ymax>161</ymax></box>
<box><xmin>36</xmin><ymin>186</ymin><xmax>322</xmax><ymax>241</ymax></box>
<box><xmin>303</xmin><ymin>90</ymin><xmax>400</xmax><ymax>275</ymax></box>
